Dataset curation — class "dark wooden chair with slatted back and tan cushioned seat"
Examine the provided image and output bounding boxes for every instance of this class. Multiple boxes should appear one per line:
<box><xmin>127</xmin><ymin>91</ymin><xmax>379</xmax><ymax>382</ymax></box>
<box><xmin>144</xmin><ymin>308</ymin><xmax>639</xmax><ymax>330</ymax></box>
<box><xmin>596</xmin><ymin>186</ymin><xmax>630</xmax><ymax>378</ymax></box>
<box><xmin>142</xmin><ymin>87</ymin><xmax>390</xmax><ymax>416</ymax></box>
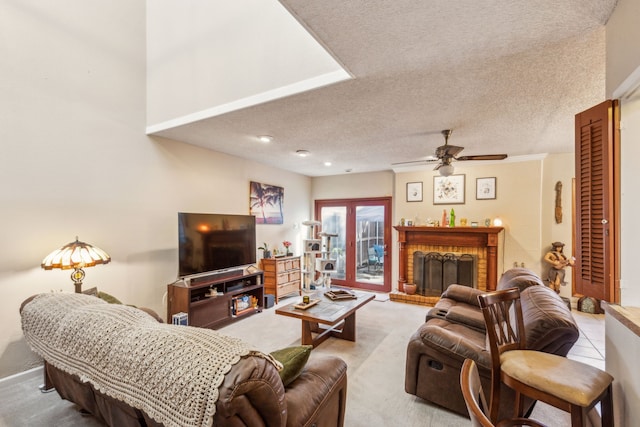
<box><xmin>478</xmin><ymin>288</ymin><xmax>613</xmax><ymax>427</ymax></box>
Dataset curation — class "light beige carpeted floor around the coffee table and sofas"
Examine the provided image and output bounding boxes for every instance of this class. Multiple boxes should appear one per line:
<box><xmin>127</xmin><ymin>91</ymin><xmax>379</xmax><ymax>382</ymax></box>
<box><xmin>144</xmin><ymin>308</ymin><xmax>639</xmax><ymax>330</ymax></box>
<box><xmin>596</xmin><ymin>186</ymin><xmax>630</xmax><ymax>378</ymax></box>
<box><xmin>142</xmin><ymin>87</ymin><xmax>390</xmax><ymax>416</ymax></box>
<box><xmin>0</xmin><ymin>297</ymin><xmax>570</xmax><ymax>427</ymax></box>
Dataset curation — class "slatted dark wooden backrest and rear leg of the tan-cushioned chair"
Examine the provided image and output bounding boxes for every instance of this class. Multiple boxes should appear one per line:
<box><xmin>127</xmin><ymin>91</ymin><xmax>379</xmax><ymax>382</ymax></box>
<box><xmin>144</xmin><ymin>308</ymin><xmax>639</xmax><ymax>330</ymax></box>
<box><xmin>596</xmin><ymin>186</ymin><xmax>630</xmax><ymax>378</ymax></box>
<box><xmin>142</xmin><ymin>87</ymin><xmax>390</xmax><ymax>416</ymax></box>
<box><xmin>478</xmin><ymin>288</ymin><xmax>527</xmax><ymax>422</ymax></box>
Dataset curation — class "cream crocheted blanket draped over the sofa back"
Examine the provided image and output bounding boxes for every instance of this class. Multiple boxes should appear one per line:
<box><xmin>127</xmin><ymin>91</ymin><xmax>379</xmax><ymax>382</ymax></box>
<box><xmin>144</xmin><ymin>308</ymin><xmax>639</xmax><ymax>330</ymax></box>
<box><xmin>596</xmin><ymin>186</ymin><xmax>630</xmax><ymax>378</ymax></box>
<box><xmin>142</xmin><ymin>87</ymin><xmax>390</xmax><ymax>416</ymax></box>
<box><xmin>22</xmin><ymin>293</ymin><xmax>279</xmax><ymax>427</ymax></box>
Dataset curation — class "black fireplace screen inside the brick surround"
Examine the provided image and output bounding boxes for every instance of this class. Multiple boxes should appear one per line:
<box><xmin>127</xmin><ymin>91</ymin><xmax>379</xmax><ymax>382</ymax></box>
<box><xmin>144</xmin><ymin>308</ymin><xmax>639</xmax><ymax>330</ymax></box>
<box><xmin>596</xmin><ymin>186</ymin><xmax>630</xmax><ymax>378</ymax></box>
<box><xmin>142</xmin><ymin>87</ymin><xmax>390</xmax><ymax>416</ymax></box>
<box><xmin>413</xmin><ymin>251</ymin><xmax>476</xmax><ymax>296</ymax></box>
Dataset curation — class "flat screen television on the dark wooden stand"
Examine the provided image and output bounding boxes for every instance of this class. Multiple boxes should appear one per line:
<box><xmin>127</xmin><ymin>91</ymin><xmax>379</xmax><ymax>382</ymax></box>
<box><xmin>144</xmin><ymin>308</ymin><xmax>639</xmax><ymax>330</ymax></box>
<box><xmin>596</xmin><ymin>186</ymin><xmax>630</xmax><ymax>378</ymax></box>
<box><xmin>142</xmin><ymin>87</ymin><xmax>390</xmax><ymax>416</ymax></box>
<box><xmin>178</xmin><ymin>212</ymin><xmax>256</xmax><ymax>277</ymax></box>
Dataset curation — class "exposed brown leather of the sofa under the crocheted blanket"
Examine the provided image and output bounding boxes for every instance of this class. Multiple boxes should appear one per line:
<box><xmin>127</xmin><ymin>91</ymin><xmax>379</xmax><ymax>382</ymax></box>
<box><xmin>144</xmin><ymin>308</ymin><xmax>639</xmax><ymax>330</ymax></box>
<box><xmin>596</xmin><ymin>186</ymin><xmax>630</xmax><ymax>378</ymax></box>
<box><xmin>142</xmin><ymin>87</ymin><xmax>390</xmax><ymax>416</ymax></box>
<box><xmin>20</xmin><ymin>297</ymin><xmax>347</xmax><ymax>427</ymax></box>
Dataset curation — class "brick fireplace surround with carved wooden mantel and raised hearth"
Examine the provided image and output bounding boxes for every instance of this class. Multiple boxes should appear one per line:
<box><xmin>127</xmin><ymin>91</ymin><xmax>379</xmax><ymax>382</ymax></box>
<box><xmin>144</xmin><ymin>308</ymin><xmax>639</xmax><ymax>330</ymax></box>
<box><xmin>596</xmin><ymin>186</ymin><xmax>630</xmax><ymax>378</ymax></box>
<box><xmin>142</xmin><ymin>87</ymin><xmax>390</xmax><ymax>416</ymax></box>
<box><xmin>391</xmin><ymin>226</ymin><xmax>504</xmax><ymax>305</ymax></box>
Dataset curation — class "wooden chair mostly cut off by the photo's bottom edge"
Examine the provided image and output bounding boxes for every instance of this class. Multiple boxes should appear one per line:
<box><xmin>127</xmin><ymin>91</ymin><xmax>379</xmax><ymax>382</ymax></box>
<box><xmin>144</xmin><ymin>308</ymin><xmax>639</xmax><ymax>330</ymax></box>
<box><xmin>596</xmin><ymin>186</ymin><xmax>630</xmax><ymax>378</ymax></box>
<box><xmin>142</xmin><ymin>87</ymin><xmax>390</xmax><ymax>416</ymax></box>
<box><xmin>460</xmin><ymin>359</ymin><xmax>545</xmax><ymax>427</ymax></box>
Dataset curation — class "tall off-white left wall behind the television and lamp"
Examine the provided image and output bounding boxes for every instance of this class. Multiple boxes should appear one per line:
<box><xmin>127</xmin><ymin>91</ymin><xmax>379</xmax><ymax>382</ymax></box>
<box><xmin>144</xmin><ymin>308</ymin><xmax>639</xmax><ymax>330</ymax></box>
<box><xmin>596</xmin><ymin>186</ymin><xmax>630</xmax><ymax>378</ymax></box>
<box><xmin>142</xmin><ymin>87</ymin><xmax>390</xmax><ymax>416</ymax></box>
<box><xmin>0</xmin><ymin>0</ymin><xmax>311</xmax><ymax>377</ymax></box>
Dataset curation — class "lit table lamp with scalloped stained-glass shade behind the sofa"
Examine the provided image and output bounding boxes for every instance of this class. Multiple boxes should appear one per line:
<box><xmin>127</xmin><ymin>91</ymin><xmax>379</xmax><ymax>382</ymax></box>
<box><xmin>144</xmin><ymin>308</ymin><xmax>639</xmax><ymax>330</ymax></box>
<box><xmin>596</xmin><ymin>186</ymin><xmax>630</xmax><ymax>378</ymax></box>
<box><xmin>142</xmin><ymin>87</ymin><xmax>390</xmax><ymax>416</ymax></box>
<box><xmin>40</xmin><ymin>237</ymin><xmax>111</xmax><ymax>293</ymax></box>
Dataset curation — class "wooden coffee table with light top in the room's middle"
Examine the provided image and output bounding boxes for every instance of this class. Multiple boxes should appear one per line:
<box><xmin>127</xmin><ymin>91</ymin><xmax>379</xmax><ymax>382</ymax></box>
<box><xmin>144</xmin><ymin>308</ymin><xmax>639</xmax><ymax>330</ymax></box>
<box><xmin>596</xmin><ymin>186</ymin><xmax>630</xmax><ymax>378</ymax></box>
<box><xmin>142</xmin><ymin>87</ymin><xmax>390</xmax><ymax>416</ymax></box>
<box><xmin>276</xmin><ymin>290</ymin><xmax>375</xmax><ymax>347</ymax></box>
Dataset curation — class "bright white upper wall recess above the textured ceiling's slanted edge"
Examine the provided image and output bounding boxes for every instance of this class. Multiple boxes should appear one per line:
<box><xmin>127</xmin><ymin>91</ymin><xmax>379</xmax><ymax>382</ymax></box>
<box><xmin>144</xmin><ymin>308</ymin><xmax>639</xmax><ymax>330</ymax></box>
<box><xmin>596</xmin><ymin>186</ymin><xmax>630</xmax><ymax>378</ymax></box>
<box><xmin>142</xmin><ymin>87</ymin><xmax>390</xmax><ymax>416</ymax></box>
<box><xmin>147</xmin><ymin>0</ymin><xmax>350</xmax><ymax>130</ymax></box>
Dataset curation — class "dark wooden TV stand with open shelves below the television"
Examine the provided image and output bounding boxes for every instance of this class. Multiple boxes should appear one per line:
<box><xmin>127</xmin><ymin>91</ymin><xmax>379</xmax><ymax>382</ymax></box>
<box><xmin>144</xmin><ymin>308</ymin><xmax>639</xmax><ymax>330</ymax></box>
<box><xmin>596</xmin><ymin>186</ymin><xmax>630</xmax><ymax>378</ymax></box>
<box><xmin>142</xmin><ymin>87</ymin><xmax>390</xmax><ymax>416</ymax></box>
<box><xmin>167</xmin><ymin>270</ymin><xmax>264</xmax><ymax>329</ymax></box>
